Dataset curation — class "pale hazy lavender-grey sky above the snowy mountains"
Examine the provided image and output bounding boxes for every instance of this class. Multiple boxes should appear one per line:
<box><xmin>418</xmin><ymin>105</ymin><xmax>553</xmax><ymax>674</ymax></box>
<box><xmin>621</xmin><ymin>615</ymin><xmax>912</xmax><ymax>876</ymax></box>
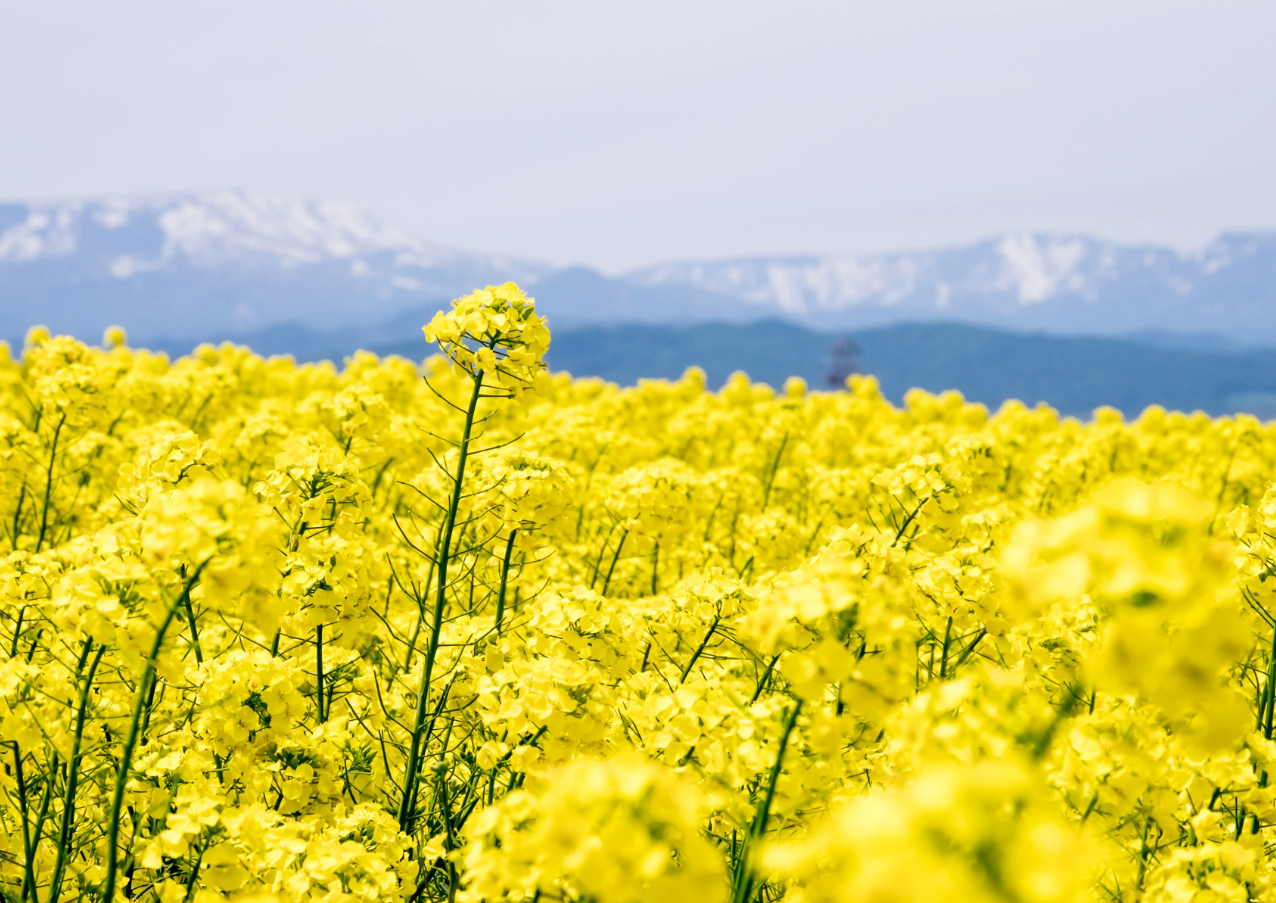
<box><xmin>0</xmin><ymin>0</ymin><xmax>1276</xmax><ymax>270</ymax></box>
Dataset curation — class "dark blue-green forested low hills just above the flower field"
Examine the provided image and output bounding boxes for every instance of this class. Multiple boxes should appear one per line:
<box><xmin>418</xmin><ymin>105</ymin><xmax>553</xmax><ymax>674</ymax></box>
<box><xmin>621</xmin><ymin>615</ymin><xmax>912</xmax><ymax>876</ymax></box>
<box><xmin>196</xmin><ymin>321</ymin><xmax>1276</xmax><ymax>418</ymax></box>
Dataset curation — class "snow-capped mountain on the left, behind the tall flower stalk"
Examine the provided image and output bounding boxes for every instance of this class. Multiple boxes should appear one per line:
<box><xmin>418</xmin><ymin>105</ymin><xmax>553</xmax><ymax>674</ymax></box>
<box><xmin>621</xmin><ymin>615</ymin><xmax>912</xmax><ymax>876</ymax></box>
<box><xmin>0</xmin><ymin>191</ymin><xmax>549</xmax><ymax>341</ymax></box>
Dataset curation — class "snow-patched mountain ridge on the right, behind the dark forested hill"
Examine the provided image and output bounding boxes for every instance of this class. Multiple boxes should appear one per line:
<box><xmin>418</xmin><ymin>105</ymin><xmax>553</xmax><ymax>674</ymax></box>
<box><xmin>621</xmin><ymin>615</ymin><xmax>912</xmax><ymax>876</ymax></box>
<box><xmin>628</xmin><ymin>232</ymin><xmax>1276</xmax><ymax>343</ymax></box>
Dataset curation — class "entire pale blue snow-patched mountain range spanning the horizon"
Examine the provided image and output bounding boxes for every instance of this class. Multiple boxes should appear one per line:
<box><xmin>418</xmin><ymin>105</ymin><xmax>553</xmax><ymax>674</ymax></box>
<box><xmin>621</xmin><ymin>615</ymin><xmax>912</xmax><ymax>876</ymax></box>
<box><xmin>7</xmin><ymin>191</ymin><xmax>1276</xmax><ymax>351</ymax></box>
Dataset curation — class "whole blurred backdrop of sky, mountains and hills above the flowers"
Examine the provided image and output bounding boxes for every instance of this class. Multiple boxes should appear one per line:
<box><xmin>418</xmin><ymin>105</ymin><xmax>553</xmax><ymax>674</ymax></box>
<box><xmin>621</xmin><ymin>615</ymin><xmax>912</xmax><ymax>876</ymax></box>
<box><xmin>0</xmin><ymin>0</ymin><xmax>1276</xmax><ymax>417</ymax></box>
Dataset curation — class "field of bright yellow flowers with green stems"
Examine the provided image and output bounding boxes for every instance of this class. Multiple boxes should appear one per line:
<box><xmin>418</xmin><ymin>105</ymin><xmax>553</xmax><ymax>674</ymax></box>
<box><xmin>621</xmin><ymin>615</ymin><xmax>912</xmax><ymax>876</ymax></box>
<box><xmin>0</xmin><ymin>284</ymin><xmax>1276</xmax><ymax>903</ymax></box>
